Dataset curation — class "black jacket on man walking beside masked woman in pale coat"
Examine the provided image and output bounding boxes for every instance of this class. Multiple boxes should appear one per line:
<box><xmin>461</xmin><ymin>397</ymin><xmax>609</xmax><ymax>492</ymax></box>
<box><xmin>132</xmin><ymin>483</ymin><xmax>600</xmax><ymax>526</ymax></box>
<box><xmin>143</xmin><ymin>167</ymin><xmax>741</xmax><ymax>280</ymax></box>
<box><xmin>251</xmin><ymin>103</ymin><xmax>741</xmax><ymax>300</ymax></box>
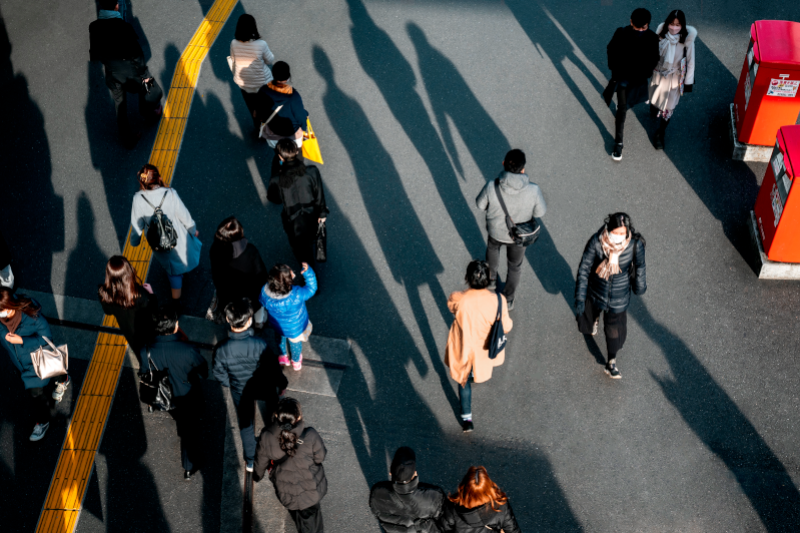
<box><xmin>607</xmin><ymin>26</ymin><xmax>661</xmax><ymax>86</ymax></box>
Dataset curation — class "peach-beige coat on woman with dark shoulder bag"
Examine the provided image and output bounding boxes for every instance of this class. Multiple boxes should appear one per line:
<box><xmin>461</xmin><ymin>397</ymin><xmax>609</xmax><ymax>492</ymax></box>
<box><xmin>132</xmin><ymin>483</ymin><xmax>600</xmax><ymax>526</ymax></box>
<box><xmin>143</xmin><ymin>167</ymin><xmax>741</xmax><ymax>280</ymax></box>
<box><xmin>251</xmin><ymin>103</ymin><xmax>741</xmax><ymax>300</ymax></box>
<box><xmin>444</xmin><ymin>289</ymin><xmax>514</xmax><ymax>387</ymax></box>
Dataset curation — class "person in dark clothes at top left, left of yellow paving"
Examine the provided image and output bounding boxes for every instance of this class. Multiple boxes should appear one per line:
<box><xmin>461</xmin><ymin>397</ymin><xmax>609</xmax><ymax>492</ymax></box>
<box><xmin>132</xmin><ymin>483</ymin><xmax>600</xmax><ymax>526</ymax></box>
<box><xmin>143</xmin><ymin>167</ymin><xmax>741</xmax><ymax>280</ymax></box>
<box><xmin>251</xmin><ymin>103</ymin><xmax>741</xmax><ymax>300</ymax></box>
<box><xmin>89</xmin><ymin>0</ymin><xmax>163</xmax><ymax>149</ymax></box>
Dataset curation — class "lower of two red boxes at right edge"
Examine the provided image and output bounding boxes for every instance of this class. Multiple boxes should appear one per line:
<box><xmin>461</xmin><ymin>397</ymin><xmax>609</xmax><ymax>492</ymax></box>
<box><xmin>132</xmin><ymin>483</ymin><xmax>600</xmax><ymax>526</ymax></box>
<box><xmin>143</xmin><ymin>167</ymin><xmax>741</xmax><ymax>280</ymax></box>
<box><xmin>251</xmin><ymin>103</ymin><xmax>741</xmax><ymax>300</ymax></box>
<box><xmin>754</xmin><ymin>126</ymin><xmax>800</xmax><ymax>263</ymax></box>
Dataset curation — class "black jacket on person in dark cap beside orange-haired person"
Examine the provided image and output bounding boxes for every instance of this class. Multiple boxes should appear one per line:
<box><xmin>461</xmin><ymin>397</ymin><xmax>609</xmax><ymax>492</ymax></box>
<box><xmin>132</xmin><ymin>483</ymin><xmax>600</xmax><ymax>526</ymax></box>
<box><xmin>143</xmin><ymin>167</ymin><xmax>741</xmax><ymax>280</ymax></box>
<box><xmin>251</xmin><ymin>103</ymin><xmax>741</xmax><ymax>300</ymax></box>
<box><xmin>369</xmin><ymin>477</ymin><xmax>445</xmax><ymax>533</ymax></box>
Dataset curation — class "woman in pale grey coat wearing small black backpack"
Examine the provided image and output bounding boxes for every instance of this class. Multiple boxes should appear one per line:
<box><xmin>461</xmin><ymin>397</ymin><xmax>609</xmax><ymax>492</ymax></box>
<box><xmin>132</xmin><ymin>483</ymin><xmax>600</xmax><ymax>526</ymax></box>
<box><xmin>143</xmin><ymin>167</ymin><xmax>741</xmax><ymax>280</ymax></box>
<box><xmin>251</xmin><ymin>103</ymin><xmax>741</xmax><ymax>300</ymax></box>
<box><xmin>131</xmin><ymin>164</ymin><xmax>203</xmax><ymax>300</ymax></box>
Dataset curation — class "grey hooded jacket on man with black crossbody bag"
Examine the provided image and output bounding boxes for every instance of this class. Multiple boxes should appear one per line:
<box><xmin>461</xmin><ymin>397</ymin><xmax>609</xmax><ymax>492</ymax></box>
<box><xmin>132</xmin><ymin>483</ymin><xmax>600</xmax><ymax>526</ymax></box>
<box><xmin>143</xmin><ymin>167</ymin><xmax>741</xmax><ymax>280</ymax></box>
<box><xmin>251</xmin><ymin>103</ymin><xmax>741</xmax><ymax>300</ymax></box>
<box><xmin>475</xmin><ymin>171</ymin><xmax>547</xmax><ymax>244</ymax></box>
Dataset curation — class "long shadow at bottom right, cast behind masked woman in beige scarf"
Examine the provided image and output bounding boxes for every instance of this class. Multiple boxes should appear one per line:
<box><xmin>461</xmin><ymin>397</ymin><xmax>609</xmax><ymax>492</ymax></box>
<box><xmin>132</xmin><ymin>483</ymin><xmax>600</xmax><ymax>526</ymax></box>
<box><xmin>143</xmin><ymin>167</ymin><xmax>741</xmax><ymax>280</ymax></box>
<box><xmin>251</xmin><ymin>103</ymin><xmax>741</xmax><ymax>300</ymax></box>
<box><xmin>629</xmin><ymin>298</ymin><xmax>800</xmax><ymax>532</ymax></box>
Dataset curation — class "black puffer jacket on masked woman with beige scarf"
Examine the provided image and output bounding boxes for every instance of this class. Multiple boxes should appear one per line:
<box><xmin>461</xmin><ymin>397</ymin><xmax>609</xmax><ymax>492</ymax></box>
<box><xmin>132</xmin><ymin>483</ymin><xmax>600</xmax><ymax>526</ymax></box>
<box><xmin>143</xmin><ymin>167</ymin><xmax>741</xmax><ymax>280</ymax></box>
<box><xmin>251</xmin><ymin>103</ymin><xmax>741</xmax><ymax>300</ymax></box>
<box><xmin>575</xmin><ymin>228</ymin><xmax>647</xmax><ymax>313</ymax></box>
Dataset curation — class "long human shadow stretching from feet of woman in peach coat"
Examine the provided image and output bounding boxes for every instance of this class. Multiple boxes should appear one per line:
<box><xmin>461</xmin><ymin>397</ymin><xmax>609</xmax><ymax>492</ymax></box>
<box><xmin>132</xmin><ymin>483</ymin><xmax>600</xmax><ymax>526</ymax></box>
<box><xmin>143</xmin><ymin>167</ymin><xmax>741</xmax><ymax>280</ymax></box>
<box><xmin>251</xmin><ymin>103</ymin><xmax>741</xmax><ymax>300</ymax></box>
<box><xmin>312</xmin><ymin>45</ymin><xmax>459</xmax><ymax>420</ymax></box>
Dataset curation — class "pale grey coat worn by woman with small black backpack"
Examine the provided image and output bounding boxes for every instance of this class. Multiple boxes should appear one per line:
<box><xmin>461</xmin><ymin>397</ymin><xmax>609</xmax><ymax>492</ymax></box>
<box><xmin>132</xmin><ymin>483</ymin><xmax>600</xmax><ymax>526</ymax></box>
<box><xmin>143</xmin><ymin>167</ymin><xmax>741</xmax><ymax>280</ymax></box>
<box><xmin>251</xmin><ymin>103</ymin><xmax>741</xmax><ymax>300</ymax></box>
<box><xmin>131</xmin><ymin>187</ymin><xmax>203</xmax><ymax>276</ymax></box>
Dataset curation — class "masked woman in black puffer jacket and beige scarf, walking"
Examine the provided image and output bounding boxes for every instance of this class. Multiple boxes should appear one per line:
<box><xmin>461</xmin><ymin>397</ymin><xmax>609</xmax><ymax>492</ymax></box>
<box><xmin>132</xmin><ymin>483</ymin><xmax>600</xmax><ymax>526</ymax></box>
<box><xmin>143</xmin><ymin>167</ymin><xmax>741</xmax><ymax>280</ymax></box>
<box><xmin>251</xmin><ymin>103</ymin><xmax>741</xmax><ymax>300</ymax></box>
<box><xmin>575</xmin><ymin>213</ymin><xmax>647</xmax><ymax>379</ymax></box>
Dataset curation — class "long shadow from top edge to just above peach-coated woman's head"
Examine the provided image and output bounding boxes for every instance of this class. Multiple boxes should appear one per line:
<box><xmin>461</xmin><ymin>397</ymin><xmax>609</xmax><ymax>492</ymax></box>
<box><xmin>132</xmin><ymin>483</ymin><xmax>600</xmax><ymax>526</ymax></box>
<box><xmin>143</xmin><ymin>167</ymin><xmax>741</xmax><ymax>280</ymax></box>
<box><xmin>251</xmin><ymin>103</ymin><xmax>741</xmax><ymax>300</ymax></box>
<box><xmin>347</xmin><ymin>0</ymin><xmax>483</xmax><ymax>257</ymax></box>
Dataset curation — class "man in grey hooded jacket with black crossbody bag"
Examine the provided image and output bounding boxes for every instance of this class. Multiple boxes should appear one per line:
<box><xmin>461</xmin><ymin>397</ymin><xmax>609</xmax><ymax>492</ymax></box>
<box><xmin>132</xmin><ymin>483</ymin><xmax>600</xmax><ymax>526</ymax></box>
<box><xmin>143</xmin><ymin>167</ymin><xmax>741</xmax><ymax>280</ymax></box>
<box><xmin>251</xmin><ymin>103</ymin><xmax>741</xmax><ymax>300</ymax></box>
<box><xmin>475</xmin><ymin>149</ymin><xmax>547</xmax><ymax>310</ymax></box>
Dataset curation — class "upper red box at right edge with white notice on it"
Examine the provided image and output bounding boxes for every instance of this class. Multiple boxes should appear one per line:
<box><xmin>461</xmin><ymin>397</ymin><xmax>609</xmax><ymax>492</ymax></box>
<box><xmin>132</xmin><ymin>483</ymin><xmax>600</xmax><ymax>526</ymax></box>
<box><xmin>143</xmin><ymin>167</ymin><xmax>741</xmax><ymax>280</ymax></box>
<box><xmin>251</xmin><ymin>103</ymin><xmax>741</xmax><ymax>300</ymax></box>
<box><xmin>733</xmin><ymin>20</ymin><xmax>800</xmax><ymax>146</ymax></box>
